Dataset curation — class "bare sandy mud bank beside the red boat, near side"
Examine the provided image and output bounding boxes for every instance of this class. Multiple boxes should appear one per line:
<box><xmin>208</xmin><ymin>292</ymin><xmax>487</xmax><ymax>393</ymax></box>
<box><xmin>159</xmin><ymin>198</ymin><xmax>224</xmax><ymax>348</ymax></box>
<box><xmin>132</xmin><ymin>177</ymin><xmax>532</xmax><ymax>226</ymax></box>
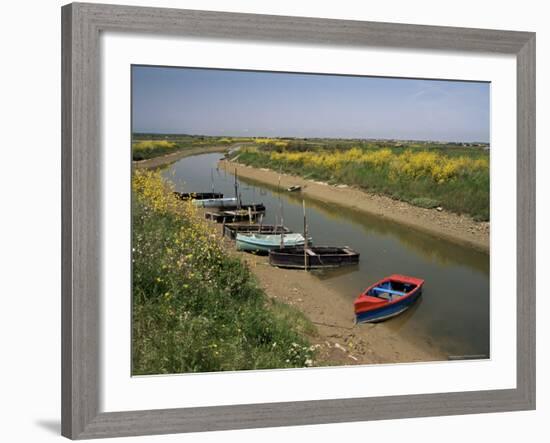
<box><xmin>205</xmin><ymin>217</ymin><xmax>447</xmax><ymax>366</ymax></box>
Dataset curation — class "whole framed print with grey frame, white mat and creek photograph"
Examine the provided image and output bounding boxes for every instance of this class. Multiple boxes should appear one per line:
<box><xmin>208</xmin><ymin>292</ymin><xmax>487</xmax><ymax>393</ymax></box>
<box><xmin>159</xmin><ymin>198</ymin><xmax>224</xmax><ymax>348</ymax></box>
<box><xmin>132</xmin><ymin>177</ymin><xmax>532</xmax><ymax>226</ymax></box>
<box><xmin>62</xmin><ymin>3</ymin><xmax>535</xmax><ymax>438</ymax></box>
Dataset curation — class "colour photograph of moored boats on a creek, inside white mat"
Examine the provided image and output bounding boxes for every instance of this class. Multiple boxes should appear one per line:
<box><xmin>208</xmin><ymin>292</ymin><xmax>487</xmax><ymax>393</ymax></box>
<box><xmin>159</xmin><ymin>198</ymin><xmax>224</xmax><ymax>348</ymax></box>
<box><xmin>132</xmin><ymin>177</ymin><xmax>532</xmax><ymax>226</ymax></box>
<box><xmin>133</xmin><ymin>65</ymin><xmax>492</xmax><ymax>376</ymax></box>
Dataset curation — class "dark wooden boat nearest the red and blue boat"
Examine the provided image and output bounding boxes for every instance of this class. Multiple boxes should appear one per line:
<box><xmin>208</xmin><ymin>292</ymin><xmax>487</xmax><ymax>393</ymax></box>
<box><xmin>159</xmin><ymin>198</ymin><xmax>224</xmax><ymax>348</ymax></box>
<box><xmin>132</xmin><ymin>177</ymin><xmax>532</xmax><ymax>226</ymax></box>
<box><xmin>269</xmin><ymin>246</ymin><xmax>359</xmax><ymax>269</ymax></box>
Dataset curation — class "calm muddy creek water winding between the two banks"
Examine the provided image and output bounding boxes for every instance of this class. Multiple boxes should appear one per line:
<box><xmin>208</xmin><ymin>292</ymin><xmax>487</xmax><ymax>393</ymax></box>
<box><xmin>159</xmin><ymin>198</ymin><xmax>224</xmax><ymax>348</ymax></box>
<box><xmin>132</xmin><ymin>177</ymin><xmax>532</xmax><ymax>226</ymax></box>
<box><xmin>163</xmin><ymin>153</ymin><xmax>490</xmax><ymax>358</ymax></box>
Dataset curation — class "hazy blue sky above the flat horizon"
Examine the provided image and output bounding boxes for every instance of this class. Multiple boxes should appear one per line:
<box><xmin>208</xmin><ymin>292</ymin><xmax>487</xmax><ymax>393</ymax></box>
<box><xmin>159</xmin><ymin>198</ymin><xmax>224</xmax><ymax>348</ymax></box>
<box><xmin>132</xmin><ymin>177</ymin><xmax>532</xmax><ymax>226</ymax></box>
<box><xmin>132</xmin><ymin>66</ymin><xmax>490</xmax><ymax>142</ymax></box>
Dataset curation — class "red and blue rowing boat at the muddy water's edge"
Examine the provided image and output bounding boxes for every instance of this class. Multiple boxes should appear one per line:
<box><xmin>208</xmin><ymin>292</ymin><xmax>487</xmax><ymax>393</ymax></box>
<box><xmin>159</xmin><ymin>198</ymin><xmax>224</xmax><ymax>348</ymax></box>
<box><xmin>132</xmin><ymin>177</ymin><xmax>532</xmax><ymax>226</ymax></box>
<box><xmin>353</xmin><ymin>274</ymin><xmax>424</xmax><ymax>323</ymax></box>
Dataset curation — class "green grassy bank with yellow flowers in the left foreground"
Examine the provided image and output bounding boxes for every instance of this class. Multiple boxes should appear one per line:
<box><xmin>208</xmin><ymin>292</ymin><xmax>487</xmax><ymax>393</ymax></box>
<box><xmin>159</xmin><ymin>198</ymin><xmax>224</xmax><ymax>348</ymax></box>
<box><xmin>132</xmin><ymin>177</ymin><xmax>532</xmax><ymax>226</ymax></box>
<box><xmin>132</xmin><ymin>170</ymin><xmax>315</xmax><ymax>375</ymax></box>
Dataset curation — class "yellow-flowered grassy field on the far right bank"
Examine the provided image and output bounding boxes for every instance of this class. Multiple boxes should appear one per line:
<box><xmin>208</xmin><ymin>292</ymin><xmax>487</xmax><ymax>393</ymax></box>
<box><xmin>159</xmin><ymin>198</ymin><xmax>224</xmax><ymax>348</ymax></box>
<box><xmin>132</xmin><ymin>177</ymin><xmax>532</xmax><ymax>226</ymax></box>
<box><xmin>235</xmin><ymin>139</ymin><xmax>489</xmax><ymax>221</ymax></box>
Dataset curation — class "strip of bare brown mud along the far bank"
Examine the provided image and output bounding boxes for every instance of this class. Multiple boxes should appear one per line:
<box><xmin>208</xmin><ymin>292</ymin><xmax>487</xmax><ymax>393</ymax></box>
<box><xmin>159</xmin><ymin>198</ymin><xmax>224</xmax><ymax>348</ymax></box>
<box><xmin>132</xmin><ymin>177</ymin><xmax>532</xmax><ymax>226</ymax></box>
<box><xmin>220</xmin><ymin>160</ymin><xmax>489</xmax><ymax>253</ymax></box>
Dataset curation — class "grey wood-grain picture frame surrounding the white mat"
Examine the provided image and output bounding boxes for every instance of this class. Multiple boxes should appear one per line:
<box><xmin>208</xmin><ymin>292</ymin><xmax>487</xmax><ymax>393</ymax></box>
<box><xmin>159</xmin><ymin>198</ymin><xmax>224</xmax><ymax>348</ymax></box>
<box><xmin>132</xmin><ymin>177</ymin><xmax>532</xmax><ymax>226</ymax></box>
<box><xmin>62</xmin><ymin>3</ymin><xmax>535</xmax><ymax>439</ymax></box>
